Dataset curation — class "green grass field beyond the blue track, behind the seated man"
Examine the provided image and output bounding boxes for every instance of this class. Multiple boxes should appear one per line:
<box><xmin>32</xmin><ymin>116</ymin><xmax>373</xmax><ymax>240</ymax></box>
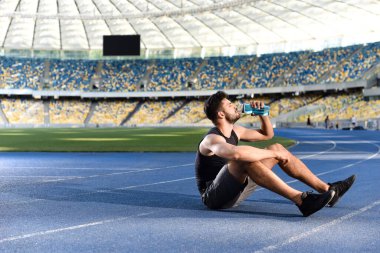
<box><xmin>0</xmin><ymin>128</ymin><xmax>295</xmax><ymax>152</ymax></box>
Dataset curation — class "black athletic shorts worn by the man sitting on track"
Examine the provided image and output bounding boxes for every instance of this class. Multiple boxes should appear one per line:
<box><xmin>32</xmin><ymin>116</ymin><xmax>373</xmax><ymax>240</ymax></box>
<box><xmin>202</xmin><ymin>164</ymin><xmax>248</xmax><ymax>209</ymax></box>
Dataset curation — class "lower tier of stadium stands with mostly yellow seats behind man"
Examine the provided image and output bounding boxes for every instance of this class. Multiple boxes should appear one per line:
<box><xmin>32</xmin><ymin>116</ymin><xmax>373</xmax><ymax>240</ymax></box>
<box><xmin>0</xmin><ymin>91</ymin><xmax>380</xmax><ymax>126</ymax></box>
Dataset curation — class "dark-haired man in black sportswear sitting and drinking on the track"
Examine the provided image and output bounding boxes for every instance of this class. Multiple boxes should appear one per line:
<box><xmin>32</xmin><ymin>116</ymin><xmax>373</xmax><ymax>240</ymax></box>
<box><xmin>195</xmin><ymin>91</ymin><xmax>355</xmax><ymax>217</ymax></box>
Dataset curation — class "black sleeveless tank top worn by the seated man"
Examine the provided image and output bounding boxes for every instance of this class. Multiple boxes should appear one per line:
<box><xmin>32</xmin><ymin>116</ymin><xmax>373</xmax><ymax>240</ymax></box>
<box><xmin>195</xmin><ymin>127</ymin><xmax>239</xmax><ymax>194</ymax></box>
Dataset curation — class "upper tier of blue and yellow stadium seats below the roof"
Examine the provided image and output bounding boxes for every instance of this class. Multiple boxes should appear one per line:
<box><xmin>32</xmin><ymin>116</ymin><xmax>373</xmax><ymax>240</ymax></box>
<box><xmin>0</xmin><ymin>42</ymin><xmax>380</xmax><ymax>92</ymax></box>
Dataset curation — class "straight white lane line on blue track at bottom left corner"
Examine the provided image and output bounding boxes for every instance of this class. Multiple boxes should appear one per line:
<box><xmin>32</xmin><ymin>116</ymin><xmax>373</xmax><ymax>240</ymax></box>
<box><xmin>0</xmin><ymin>212</ymin><xmax>154</xmax><ymax>243</ymax></box>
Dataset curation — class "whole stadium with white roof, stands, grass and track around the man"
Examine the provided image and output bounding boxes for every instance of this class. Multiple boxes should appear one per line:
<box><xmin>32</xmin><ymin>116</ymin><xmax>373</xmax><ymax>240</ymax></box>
<box><xmin>0</xmin><ymin>0</ymin><xmax>380</xmax><ymax>252</ymax></box>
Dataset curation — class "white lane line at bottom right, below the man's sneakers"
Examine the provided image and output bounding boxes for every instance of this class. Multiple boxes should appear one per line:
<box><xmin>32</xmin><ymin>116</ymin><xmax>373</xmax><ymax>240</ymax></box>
<box><xmin>254</xmin><ymin>200</ymin><xmax>380</xmax><ymax>253</ymax></box>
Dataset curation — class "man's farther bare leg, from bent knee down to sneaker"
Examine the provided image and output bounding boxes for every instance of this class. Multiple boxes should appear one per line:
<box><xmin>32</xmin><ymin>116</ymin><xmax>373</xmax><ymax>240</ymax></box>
<box><xmin>261</xmin><ymin>144</ymin><xmax>329</xmax><ymax>193</ymax></box>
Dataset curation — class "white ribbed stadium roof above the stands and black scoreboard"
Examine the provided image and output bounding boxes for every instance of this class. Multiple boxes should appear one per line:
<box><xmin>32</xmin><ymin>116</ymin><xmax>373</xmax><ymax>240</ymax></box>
<box><xmin>0</xmin><ymin>0</ymin><xmax>380</xmax><ymax>57</ymax></box>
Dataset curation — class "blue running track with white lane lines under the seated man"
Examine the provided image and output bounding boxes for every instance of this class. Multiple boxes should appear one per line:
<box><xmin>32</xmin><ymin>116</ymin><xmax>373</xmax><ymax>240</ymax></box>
<box><xmin>0</xmin><ymin>129</ymin><xmax>380</xmax><ymax>253</ymax></box>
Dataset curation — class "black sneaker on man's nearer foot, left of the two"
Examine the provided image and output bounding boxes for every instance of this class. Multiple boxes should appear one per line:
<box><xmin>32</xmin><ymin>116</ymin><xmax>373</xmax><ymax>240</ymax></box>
<box><xmin>297</xmin><ymin>190</ymin><xmax>335</xmax><ymax>217</ymax></box>
